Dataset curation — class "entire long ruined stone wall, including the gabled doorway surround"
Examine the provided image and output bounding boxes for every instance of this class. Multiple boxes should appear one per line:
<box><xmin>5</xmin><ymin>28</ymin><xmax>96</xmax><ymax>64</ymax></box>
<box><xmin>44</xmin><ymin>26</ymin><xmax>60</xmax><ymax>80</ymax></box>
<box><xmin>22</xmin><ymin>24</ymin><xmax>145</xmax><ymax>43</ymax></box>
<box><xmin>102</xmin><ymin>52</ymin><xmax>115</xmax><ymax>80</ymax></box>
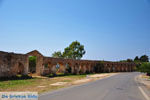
<box><xmin>0</xmin><ymin>50</ymin><xmax>136</xmax><ymax>77</ymax></box>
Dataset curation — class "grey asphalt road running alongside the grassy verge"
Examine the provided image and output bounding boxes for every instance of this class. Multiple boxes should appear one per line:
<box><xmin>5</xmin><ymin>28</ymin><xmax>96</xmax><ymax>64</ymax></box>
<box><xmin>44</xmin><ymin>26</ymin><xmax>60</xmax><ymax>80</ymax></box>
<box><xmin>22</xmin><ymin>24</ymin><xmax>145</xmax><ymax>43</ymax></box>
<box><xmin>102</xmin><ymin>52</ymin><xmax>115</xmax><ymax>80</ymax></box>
<box><xmin>39</xmin><ymin>72</ymin><xmax>146</xmax><ymax>100</ymax></box>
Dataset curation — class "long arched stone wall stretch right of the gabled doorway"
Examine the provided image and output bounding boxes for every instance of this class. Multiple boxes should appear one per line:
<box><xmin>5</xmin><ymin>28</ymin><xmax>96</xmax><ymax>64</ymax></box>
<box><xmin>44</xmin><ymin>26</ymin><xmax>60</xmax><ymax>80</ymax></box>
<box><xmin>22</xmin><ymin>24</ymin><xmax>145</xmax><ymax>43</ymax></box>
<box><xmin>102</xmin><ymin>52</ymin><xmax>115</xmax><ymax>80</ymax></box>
<box><xmin>43</xmin><ymin>57</ymin><xmax>136</xmax><ymax>74</ymax></box>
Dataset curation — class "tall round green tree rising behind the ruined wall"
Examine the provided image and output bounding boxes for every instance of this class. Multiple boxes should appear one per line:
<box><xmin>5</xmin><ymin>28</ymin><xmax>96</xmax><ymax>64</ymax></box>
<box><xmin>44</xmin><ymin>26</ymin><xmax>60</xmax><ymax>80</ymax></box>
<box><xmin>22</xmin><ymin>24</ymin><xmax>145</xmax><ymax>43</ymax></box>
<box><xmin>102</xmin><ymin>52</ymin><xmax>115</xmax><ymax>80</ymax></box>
<box><xmin>63</xmin><ymin>41</ymin><xmax>85</xmax><ymax>59</ymax></box>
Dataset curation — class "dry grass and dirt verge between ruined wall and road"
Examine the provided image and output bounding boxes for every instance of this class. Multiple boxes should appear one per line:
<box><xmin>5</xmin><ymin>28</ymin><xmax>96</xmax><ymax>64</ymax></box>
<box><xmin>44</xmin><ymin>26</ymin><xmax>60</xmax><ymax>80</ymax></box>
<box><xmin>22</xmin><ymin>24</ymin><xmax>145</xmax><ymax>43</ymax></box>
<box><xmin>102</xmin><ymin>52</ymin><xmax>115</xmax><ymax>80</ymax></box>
<box><xmin>0</xmin><ymin>74</ymin><xmax>116</xmax><ymax>93</ymax></box>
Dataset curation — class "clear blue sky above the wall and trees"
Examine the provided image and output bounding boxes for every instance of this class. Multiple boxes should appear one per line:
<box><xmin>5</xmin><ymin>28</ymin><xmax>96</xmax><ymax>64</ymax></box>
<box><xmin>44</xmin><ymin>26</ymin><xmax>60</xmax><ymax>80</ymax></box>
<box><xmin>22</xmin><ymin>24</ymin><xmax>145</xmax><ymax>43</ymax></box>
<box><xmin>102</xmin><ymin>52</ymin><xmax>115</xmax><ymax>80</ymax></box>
<box><xmin>0</xmin><ymin>0</ymin><xmax>150</xmax><ymax>61</ymax></box>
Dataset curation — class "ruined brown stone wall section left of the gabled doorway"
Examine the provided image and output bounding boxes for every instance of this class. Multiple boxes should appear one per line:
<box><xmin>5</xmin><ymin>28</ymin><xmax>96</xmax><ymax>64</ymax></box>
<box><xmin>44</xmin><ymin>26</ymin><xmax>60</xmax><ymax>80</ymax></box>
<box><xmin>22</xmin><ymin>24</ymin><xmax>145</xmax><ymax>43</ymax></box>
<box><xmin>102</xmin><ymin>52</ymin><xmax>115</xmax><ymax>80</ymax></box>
<box><xmin>0</xmin><ymin>51</ymin><xmax>28</xmax><ymax>77</ymax></box>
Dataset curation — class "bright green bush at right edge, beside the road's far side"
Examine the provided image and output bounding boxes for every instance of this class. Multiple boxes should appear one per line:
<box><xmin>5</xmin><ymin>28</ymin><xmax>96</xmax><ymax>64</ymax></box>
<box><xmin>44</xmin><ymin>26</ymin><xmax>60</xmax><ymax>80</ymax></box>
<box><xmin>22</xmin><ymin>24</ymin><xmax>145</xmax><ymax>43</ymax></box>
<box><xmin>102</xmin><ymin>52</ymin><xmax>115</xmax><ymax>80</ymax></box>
<box><xmin>138</xmin><ymin>62</ymin><xmax>150</xmax><ymax>75</ymax></box>
